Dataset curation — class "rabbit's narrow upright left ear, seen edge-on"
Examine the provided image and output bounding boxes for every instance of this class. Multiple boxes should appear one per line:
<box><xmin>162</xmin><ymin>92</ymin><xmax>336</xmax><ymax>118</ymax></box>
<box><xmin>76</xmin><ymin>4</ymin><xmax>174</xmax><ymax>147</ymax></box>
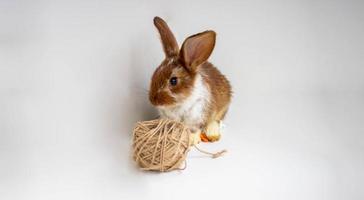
<box><xmin>153</xmin><ymin>17</ymin><xmax>179</xmax><ymax>57</ymax></box>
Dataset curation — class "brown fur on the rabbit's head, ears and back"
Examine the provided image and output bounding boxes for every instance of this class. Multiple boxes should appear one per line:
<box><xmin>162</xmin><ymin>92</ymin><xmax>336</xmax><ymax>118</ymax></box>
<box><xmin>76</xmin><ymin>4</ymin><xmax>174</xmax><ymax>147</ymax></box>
<box><xmin>149</xmin><ymin>17</ymin><xmax>232</xmax><ymax>138</ymax></box>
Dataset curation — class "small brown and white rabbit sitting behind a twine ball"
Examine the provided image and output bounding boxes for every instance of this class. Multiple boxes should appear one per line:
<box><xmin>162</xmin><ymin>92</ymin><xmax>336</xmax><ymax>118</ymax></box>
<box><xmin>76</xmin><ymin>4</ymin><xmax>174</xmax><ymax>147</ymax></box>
<box><xmin>149</xmin><ymin>17</ymin><xmax>232</xmax><ymax>142</ymax></box>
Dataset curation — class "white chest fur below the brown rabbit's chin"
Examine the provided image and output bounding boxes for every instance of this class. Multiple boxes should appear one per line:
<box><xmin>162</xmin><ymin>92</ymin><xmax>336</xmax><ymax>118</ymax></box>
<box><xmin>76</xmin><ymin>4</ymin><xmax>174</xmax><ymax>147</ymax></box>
<box><xmin>158</xmin><ymin>75</ymin><xmax>210</xmax><ymax>128</ymax></box>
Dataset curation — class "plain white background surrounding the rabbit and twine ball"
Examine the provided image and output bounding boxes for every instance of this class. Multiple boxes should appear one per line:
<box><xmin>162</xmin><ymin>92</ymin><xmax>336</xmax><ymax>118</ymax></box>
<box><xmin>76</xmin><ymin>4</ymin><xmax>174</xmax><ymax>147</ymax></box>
<box><xmin>0</xmin><ymin>0</ymin><xmax>364</xmax><ymax>200</ymax></box>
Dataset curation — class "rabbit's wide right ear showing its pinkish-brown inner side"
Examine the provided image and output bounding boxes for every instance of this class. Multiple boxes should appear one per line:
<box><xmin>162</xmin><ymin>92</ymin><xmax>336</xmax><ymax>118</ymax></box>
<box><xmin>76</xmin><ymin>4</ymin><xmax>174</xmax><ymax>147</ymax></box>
<box><xmin>180</xmin><ymin>31</ymin><xmax>216</xmax><ymax>71</ymax></box>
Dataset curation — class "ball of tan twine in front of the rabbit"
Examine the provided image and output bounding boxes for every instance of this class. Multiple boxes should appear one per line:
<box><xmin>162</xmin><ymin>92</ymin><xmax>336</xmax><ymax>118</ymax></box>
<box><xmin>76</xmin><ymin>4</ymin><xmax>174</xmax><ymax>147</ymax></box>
<box><xmin>133</xmin><ymin>119</ymin><xmax>191</xmax><ymax>172</ymax></box>
